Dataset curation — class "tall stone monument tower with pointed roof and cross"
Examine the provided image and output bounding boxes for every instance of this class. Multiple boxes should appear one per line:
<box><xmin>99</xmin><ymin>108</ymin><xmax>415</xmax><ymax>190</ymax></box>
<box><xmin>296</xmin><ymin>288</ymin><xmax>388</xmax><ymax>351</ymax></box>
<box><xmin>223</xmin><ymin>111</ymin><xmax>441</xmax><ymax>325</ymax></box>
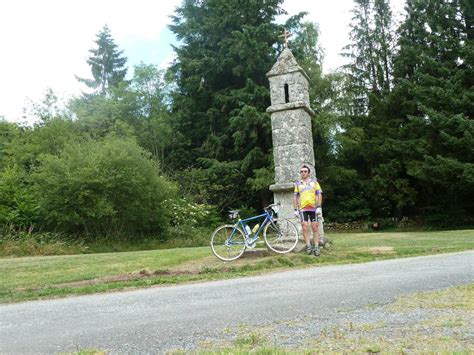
<box><xmin>267</xmin><ymin>30</ymin><xmax>316</xmax><ymax>220</ymax></box>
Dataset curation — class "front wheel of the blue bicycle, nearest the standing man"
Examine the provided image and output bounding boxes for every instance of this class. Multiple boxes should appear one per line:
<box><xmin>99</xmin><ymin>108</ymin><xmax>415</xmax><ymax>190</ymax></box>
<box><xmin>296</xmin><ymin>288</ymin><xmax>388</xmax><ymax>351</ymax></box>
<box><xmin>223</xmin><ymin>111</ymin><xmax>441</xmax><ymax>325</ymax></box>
<box><xmin>263</xmin><ymin>218</ymin><xmax>298</xmax><ymax>254</ymax></box>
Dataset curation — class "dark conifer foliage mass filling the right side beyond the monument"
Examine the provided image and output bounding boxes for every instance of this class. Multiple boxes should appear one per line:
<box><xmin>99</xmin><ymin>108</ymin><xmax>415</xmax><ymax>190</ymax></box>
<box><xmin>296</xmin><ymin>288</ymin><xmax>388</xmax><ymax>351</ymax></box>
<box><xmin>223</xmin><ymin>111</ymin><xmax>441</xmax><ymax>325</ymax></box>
<box><xmin>336</xmin><ymin>0</ymin><xmax>474</xmax><ymax>225</ymax></box>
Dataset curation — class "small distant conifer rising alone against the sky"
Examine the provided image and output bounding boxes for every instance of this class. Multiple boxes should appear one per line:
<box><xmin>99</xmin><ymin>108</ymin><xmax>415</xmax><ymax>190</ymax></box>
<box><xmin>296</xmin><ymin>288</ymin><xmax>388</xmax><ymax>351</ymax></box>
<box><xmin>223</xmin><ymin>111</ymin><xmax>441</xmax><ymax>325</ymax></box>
<box><xmin>76</xmin><ymin>25</ymin><xmax>127</xmax><ymax>96</ymax></box>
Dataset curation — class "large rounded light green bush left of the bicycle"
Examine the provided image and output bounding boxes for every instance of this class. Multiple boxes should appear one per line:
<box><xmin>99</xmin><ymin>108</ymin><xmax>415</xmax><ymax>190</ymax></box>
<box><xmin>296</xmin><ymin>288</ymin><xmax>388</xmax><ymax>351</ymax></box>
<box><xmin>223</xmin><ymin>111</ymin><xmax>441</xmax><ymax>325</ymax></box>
<box><xmin>32</xmin><ymin>136</ymin><xmax>174</xmax><ymax>236</ymax></box>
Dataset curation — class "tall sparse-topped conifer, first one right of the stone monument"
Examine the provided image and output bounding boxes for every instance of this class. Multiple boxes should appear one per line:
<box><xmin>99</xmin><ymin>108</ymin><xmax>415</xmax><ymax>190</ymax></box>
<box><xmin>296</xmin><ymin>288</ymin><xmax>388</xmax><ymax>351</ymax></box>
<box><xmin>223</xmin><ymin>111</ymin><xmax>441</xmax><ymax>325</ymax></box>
<box><xmin>336</xmin><ymin>0</ymin><xmax>398</xmax><ymax>218</ymax></box>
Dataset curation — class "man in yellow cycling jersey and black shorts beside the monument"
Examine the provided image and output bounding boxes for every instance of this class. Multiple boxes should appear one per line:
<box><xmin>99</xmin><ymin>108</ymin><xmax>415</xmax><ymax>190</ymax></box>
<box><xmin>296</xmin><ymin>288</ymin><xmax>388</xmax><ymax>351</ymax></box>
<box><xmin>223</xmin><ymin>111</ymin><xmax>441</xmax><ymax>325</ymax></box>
<box><xmin>293</xmin><ymin>165</ymin><xmax>322</xmax><ymax>256</ymax></box>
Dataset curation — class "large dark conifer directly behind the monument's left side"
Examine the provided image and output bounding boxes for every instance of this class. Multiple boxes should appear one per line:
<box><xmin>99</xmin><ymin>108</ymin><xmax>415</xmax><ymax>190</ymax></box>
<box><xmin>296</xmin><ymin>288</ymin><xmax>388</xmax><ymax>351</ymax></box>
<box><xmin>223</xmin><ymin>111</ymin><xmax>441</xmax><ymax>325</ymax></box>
<box><xmin>170</xmin><ymin>0</ymin><xmax>283</xmax><ymax>208</ymax></box>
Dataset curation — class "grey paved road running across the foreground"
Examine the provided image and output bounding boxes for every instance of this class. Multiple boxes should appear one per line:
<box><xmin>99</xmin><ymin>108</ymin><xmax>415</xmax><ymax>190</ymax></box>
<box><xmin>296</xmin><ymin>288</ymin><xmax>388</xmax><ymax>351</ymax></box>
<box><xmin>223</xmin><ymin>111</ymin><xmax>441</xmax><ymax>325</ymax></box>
<box><xmin>0</xmin><ymin>251</ymin><xmax>474</xmax><ymax>354</ymax></box>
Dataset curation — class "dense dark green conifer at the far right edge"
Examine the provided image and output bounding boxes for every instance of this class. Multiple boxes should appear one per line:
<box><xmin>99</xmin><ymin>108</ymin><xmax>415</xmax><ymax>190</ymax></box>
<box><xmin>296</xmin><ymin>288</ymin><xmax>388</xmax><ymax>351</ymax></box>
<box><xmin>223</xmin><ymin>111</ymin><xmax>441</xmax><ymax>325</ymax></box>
<box><xmin>386</xmin><ymin>0</ymin><xmax>474</xmax><ymax>224</ymax></box>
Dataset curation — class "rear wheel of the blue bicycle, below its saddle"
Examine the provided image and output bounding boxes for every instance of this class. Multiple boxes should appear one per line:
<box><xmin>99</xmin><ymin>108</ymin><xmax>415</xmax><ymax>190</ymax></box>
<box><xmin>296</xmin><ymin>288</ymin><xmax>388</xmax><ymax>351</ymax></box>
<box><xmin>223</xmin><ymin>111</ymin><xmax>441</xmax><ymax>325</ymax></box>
<box><xmin>211</xmin><ymin>224</ymin><xmax>245</xmax><ymax>261</ymax></box>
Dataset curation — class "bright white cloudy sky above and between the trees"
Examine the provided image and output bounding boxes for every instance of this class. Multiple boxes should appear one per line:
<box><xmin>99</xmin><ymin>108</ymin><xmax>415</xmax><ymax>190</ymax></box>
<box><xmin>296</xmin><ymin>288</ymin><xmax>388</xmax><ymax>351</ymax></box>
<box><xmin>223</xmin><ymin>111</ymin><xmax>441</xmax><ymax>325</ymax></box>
<box><xmin>0</xmin><ymin>0</ymin><xmax>403</xmax><ymax>122</ymax></box>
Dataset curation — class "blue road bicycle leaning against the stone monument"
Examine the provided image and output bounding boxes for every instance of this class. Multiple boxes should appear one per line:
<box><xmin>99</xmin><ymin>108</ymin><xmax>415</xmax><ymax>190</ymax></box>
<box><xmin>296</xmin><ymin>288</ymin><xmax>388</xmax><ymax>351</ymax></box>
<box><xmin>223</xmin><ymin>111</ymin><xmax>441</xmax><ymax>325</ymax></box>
<box><xmin>211</xmin><ymin>203</ymin><xmax>298</xmax><ymax>261</ymax></box>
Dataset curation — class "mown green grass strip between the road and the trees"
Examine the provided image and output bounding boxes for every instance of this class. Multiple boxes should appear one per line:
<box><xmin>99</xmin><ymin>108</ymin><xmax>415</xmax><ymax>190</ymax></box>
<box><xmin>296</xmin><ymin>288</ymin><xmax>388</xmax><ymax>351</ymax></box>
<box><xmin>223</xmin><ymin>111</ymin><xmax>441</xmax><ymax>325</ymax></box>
<box><xmin>0</xmin><ymin>230</ymin><xmax>474</xmax><ymax>302</ymax></box>
